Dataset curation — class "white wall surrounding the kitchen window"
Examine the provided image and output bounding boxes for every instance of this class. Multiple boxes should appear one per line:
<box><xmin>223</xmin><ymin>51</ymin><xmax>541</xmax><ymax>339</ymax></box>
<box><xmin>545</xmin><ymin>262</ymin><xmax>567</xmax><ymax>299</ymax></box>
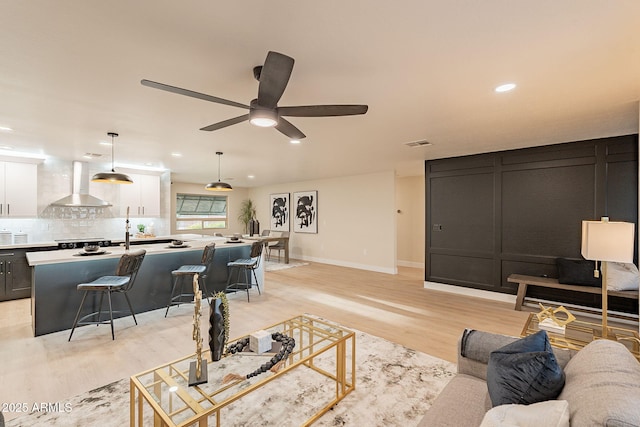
<box><xmin>169</xmin><ymin>182</ymin><xmax>249</xmax><ymax>234</ymax></box>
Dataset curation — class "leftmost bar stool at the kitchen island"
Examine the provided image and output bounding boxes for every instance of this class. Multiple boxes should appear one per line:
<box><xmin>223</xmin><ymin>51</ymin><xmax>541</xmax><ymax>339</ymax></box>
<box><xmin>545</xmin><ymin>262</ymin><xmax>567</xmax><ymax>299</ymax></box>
<box><xmin>69</xmin><ymin>249</ymin><xmax>146</xmax><ymax>341</ymax></box>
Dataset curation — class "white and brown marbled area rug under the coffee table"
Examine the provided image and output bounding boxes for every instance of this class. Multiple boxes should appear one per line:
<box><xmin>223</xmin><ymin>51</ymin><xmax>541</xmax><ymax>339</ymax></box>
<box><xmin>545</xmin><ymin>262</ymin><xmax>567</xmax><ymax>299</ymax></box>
<box><xmin>6</xmin><ymin>322</ymin><xmax>455</xmax><ymax>427</ymax></box>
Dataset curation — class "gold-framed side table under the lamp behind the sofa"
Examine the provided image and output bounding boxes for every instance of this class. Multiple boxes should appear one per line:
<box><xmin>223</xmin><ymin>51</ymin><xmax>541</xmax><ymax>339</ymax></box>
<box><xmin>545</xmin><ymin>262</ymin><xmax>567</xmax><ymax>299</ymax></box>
<box><xmin>520</xmin><ymin>313</ymin><xmax>640</xmax><ymax>360</ymax></box>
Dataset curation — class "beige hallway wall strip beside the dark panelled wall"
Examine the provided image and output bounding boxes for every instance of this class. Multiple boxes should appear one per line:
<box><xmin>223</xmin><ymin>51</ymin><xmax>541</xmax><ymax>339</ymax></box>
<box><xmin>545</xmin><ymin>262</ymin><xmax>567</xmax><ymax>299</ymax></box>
<box><xmin>396</xmin><ymin>176</ymin><xmax>425</xmax><ymax>268</ymax></box>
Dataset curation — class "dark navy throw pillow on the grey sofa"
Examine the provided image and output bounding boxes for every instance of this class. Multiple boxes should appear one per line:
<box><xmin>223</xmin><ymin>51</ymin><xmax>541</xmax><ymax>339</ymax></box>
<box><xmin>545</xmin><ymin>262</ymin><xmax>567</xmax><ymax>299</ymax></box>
<box><xmin>487</xmin><ymin>331</ymin><xmax>564</xmax><ymax>406</ymax></box>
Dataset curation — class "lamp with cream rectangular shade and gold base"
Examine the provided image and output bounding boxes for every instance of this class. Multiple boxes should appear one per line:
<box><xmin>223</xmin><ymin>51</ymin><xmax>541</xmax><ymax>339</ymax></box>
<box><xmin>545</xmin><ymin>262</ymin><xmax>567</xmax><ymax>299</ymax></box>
<box><xmin>581</xmin><ymin>217</ymin><xmax>635</xmax><ymax>338</ymax></box>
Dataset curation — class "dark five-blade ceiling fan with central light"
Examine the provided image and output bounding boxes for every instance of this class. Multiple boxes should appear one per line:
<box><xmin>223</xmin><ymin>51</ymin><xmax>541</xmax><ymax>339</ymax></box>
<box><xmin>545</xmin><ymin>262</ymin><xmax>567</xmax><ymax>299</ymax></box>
<box><xmin>140</xmin><ymin>51</ymin><xmax>369</xmax><ymax>140</ymax></box>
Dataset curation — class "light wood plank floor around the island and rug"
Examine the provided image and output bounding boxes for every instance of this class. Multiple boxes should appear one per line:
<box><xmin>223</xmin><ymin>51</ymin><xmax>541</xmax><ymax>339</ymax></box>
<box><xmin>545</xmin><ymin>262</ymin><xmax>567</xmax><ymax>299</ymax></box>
<box><xmin>0</xmin><ymin>263</ymin><xmax>527</xmax><ymax>419</ymax></box>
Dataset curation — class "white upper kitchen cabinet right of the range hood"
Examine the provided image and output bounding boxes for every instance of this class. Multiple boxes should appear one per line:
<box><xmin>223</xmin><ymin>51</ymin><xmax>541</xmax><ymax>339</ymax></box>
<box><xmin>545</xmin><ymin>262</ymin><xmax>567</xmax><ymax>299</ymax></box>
<box><xmin>120</xmin><ymin>174</ymin><xmax>160</xmax><ymax>217</ymax></box>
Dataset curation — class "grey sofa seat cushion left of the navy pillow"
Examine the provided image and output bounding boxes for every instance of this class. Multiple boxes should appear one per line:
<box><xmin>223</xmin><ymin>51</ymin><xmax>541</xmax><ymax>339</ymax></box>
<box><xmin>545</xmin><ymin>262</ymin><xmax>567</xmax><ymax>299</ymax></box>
<box><xmin>418</xmin><ymin>374</ymin><xmax>488</xmax><ymax>427</ymax></box>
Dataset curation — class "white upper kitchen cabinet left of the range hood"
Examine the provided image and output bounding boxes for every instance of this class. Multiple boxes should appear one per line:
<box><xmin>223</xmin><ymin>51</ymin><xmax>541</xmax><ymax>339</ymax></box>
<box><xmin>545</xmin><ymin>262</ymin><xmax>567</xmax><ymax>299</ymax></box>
<box><xmin>0</xmin><ymin>162</ymin><xmax>38</xmax><ymax>217</ymax></box>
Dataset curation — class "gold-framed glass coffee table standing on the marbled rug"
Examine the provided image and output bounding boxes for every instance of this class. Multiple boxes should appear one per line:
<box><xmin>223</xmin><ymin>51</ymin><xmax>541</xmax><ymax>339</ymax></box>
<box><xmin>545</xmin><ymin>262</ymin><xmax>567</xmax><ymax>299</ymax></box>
<box><xmin>130</xmin><ymin>315</ymin><xmax>356</xmax><ymax>427</ymax></box>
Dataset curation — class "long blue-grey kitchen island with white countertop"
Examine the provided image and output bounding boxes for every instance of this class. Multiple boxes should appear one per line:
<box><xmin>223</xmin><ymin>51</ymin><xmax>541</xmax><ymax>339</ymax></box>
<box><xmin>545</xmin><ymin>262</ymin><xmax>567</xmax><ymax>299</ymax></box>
<box><xmin>27</xmin><ymin>237</ymin><xmax>264</xmax><ymax>336</ymax></box>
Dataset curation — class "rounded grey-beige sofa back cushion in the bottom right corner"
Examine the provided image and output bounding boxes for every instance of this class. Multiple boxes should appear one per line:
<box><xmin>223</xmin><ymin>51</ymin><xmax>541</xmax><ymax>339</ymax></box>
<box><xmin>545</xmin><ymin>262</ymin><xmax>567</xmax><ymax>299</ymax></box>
<box><xmin>559</xmin><ymin>339</ymin><xmax>640</xmax><ymax>426</ymax></box>
